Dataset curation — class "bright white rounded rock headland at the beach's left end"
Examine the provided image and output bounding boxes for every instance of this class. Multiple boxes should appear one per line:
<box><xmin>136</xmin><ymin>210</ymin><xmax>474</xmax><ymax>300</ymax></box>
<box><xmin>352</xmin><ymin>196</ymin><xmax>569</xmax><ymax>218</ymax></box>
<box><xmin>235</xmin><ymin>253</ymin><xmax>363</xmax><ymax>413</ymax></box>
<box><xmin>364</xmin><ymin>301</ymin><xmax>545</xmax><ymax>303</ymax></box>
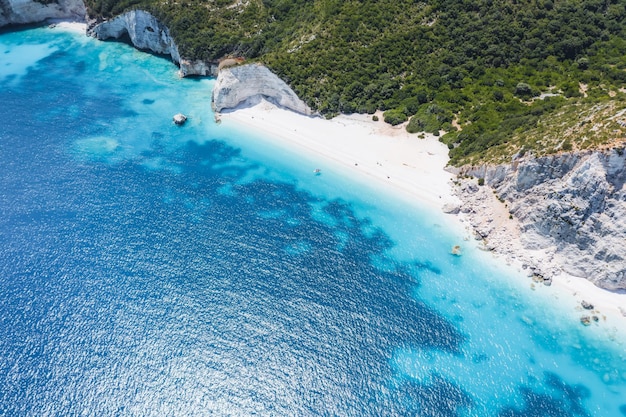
<box><xmin>213</xmin><ymin>64</ymin><xmax>311</xmax><ymax>115</ymax></box>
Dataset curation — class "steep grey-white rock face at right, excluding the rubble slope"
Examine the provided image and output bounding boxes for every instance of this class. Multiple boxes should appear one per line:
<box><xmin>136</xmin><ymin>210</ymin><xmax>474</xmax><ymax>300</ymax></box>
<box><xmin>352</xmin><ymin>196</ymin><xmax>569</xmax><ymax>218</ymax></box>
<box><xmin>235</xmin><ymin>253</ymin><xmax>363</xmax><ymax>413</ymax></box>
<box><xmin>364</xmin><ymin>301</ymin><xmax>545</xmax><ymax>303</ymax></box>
<box><xmin>460</xmin><ymin>149</ymin><xmax>626</xmax><ymax>290</ymax></box>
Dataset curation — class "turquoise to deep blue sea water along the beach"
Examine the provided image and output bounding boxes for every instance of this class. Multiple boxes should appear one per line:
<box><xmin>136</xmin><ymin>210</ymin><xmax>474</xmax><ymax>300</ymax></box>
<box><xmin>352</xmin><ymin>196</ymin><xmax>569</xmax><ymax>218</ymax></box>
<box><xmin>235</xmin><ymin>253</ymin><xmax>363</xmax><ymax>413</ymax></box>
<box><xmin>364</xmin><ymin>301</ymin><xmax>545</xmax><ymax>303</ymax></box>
<box><xmin>0</xmin><ymin>28</ymin><xmax>626</xmax><ymax>416</ymax></box>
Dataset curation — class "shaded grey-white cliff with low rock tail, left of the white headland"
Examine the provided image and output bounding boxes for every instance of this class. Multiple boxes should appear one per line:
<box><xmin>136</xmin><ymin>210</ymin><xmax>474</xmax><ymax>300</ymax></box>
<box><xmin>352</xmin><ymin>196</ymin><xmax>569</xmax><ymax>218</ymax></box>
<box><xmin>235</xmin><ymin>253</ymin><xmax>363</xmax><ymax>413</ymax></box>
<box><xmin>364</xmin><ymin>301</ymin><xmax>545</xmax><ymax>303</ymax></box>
<box><xmin>86</xmin><ymin>10</ymin><xmax>217</xmax><ymax>77</ymax></box>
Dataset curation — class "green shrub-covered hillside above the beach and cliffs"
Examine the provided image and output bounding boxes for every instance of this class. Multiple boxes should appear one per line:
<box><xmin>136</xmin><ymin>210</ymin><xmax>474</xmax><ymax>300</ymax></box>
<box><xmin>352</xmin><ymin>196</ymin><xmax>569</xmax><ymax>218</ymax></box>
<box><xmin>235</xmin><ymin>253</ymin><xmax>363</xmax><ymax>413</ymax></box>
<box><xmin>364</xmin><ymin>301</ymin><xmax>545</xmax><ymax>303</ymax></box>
<box><xmin>87</xmin><ymin>0</ymin><xmax>626</xmax><ymax>164</ymax></box>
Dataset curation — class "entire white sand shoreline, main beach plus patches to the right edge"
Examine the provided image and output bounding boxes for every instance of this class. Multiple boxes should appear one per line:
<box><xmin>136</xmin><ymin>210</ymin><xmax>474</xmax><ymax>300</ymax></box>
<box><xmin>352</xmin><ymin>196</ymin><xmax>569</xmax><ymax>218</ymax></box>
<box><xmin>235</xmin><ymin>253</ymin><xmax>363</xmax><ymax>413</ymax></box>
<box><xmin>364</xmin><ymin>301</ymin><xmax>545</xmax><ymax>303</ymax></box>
<box><xmin>220</xmin><ymin>101</ymin><xmax>626</xmax><ymax>332</ymax></box>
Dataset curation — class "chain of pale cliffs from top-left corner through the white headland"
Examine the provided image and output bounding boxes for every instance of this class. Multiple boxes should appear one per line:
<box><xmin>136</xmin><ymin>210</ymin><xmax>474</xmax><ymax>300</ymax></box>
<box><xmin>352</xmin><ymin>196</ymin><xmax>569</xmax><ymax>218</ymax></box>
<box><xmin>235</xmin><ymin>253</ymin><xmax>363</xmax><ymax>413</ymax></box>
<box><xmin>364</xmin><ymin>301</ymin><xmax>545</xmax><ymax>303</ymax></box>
<box><xmin>0</xmin><ymin>0</ymin><xmax>311</xmax><ymax>115</ymax></box>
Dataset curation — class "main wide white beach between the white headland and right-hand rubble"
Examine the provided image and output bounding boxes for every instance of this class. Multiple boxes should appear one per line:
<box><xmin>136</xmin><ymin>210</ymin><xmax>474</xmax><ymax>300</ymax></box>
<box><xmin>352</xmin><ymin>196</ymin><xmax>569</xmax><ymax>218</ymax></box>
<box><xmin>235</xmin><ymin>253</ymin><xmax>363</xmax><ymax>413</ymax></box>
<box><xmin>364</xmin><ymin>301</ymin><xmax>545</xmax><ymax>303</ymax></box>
<box><xmin>220</xmin><ymin>101</ymin><xmax>460</xmax><ymax>210</ymax></box>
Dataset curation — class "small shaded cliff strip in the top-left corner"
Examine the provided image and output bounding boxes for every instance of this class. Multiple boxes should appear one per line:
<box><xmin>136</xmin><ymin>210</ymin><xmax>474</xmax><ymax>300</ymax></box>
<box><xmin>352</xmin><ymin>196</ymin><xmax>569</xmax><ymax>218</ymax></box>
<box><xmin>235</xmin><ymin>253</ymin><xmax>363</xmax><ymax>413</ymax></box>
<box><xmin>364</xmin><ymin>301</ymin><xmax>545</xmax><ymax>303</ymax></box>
<box><xmin>0</xmin><ymin>0</ymin><xmax>87</xmax><ymax>27</ymax></box>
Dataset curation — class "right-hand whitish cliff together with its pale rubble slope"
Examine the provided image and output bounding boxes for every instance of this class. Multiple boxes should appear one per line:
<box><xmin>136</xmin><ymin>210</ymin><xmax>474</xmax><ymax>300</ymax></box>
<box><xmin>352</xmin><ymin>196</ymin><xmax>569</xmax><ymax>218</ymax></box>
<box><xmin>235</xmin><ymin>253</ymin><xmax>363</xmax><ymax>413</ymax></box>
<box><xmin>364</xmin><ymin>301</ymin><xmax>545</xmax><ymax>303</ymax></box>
<box><xmin>448</xmin><ymin>148</ymin><xmax>626</xmax><ymax>291</ymax></box>
